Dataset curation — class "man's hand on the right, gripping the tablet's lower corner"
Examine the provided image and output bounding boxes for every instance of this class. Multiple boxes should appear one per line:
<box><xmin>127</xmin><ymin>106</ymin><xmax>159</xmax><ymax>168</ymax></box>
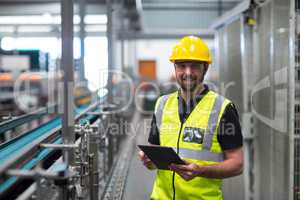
<box><xmin>170</xmin><ymin>161</ymin><xmax>201</xmax><ymax>181</ymax></box>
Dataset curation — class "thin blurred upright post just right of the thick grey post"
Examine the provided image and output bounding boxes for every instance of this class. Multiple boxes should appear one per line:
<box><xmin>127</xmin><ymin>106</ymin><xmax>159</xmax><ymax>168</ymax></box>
<box><xmin>79</xmin><ymin>0</ymin><xmax>86</xmax><ymax>81</ymax></box>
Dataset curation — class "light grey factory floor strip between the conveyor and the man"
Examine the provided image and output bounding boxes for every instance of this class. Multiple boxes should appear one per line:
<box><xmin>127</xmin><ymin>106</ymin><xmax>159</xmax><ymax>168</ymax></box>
<box><xmin>123</xmin><ymin>112</ymin><xmax>155</xmax><ymax>200</ymax></box>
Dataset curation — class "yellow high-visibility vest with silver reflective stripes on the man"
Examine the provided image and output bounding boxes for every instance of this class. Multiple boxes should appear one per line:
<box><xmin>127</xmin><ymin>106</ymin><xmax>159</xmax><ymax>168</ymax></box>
<box><xmin>151</xmin><ymin>91</ymin><xmax>231</xmax><ymax>200</ymax></box>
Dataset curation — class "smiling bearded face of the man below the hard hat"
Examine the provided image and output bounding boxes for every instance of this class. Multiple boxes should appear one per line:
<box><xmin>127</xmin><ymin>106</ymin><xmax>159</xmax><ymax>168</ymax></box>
<box><xmin>174</xmin><ymin>61</ymin><xmax>208</xmax><ymax>92</ymax></box>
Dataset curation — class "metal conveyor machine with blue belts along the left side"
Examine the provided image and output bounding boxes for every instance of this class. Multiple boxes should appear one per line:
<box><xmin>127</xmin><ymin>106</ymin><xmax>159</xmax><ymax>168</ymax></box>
<box><xmin>0</xmin><ymin>100</ymin><xmax>133</xmax><ymax>199</ymax></box>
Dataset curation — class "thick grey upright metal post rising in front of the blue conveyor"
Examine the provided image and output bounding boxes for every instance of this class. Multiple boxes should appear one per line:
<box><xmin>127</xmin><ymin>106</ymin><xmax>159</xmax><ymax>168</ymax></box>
<box><xmin>61</xmin><ymin>0</ymin><xmax>75</xmax><ymax>165</ymax></box>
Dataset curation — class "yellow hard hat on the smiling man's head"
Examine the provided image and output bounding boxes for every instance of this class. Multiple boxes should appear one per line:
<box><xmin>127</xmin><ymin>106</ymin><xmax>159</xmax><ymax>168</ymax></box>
<box><xmin>169</xmin><ymin>36</ymin><xmax>212</xmax><ymax>64</ymax></box>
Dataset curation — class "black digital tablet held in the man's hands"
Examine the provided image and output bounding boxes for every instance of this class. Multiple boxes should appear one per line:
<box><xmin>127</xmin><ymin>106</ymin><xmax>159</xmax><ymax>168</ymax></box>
<box><xmin>137</xmin><ymin>145</ymin><xmax>185</xmax><ymax>170</ymax></box>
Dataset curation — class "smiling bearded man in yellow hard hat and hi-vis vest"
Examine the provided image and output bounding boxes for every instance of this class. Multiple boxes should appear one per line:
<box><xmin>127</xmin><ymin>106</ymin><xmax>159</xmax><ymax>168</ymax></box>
<box><xmin>139</xmin><ymin>36</ymin><xmax>243</xmax><ymax>200</ymax></box>
